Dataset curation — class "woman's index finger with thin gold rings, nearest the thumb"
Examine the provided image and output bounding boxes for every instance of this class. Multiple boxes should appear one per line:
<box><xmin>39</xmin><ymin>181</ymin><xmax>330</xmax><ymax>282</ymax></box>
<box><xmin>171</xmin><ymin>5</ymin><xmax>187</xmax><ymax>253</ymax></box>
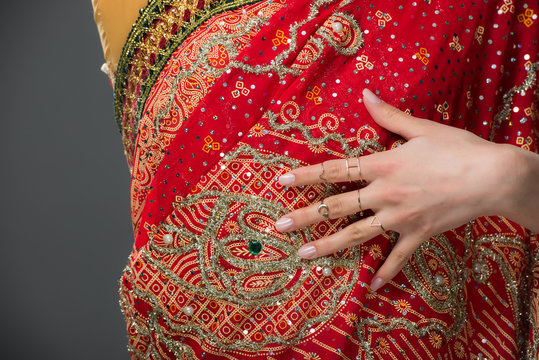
<box><xmin>279</xmin><ymin>153</ymin><xmax>380</xmax><ymax>186</ymax></box>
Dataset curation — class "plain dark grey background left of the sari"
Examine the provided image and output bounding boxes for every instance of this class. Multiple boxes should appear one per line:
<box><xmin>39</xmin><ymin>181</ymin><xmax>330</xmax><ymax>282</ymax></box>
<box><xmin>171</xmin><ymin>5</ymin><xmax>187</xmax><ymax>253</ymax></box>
<box><xmin>0</xmin><ymin>0</ymin><xmax>133</xmax><ymax>359</ymax></box>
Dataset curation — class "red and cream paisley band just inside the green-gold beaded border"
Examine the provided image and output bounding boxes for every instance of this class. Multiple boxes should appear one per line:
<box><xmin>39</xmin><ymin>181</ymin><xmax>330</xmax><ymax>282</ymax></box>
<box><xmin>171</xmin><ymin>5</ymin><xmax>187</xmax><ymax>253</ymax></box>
<box><xmin>131</xmin><ymin>2</ymin><xmax>283</xmax><ymax>228</ymax></box>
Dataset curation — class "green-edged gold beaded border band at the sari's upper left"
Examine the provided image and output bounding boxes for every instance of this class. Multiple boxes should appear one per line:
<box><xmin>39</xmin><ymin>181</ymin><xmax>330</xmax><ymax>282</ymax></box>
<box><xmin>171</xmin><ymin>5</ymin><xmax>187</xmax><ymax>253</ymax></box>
<box><xmin>115</xmin><ymin>0</ymin><xmax>272</xmax><ymax>167</ymax></box>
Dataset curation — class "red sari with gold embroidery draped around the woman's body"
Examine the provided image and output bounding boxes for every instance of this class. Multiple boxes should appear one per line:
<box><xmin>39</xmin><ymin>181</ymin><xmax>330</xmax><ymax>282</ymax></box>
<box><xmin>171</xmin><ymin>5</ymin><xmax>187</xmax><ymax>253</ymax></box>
<box><xmin>116</xmin><ymin>0</ymin><xmax>539</xmax><ymax>360</ymax></box>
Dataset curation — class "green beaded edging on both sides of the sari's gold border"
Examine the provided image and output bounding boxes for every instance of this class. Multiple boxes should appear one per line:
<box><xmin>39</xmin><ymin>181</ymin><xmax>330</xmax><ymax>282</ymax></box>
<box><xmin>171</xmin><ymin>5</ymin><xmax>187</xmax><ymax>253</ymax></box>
<box><xmin>114</xmin><ymin>0</ymin><xmax>261</xmax><ymax>136</ymax></box>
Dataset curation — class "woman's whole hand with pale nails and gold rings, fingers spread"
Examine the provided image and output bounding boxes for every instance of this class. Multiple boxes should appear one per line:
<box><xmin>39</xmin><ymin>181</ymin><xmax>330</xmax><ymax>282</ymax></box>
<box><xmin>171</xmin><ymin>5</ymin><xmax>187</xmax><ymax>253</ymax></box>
<box><xmin>275</xmin><ymin>90</ymin><xmax>539</xmax><ymax>291</ymax></box>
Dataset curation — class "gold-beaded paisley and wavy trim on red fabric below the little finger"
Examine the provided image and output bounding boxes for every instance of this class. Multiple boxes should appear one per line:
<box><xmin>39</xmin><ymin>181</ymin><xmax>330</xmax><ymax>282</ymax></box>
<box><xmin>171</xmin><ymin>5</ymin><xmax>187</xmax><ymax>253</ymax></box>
<box><xmin>350</xmin><ymin>219</ymin><xmax>539</xmax><ymax>360</ymax></box>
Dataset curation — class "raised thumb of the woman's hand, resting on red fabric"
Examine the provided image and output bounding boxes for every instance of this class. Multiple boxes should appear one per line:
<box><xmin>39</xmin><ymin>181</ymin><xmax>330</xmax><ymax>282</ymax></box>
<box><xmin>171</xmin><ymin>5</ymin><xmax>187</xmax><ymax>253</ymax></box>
<box><xmin>363</xmin><ymin>89</ymin><xmax>431</xmax><ymax>140</ymax></box>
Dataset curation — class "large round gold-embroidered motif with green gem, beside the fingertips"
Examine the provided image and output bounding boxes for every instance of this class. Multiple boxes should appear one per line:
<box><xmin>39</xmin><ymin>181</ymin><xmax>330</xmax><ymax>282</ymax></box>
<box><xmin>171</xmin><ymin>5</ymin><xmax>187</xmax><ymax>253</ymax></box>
<box><xmin>123</xmin><ymin>146</ymin><xmax>362</xmax><ymax>353</ymax></box>
